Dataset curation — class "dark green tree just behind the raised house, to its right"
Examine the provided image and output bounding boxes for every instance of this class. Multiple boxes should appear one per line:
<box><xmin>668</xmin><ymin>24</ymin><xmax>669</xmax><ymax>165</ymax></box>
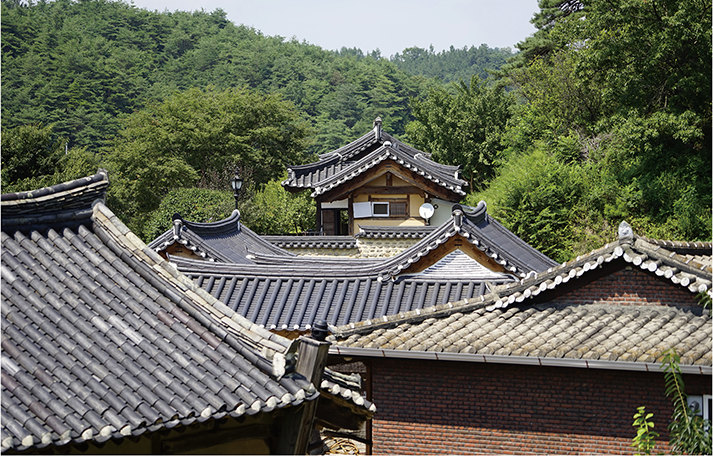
<box><xmin>407</xmin><ymin>76</ymin><xmax>513</xmax><ymax>188</ymax></box>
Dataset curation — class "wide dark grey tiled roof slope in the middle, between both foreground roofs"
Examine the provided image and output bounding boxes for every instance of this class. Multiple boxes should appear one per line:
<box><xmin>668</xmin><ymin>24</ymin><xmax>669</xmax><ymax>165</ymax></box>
<box><xmin>177</xmin><ymin>259</ymin><xmax>512</xmax><ymax>331</ymax></box>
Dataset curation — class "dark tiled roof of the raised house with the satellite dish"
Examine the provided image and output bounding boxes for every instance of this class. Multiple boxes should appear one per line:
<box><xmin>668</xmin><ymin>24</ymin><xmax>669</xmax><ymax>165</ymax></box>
<box><xmin>282</xmin><ymin>119</ymin><xmax>468</xmax><ymax>197</ymax></box>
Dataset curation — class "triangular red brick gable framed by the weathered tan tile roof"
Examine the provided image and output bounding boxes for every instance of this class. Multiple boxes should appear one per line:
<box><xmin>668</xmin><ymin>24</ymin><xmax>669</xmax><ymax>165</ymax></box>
<box><xmin>551</xmin><ymin>266</ymin><xmax>698</xmax><ymax>306</ymax></box>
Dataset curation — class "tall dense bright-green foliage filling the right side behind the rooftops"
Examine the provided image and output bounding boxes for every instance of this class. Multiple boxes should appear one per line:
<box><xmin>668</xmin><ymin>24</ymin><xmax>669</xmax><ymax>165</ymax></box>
<box><xmin>469</xmin><ymin>0</ymin><xmax>711</xmax><ymax>261</ymax></box>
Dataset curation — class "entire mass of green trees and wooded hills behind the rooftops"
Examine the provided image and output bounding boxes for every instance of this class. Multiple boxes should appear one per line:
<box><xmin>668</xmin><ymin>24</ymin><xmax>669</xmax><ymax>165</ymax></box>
<box><xmin>2</xmin><ymin>0</ymin><xmax>712</xmax><ymax>261</ymax></box>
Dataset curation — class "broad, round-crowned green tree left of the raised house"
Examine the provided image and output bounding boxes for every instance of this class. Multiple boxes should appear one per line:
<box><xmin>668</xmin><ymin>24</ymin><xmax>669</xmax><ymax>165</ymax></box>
<box><xmin>107</xmin><ymin>87</ymin><xmax>309</xmax><ymax>231</ymax></box>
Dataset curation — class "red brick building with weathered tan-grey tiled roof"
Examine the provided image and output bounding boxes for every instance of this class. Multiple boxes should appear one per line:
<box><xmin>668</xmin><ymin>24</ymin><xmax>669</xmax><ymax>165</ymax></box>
<box><xmin>330</xmin><ymin>224</ymin><xmax>713</xmax><ymax>454</ymax></box>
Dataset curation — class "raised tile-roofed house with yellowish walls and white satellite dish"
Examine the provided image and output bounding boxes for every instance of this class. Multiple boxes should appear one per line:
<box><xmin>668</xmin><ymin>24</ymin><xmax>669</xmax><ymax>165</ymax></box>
<box><xmin>282</xmin><ymin>118</ymin><xmax>467</xmax><ymax>236</ymax></box>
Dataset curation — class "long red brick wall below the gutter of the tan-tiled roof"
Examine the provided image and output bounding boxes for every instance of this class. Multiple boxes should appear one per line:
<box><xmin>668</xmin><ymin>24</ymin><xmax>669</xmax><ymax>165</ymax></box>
<box><xmin>369</xmin><ymin>359</ymin><xmax>711</xmax><ymax>454</ymax></box>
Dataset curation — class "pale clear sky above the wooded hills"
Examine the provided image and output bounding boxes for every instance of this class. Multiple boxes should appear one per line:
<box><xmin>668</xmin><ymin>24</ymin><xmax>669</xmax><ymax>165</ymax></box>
<box><xmin>126</xmin><ymin>0</ymin><xmax>538</xmax><ymax>57</ymax></box>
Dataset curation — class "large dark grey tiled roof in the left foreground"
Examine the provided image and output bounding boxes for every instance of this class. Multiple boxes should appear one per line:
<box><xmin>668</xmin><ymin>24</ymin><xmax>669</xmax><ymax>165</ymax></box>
<box><xmin>1</xmin><ymin>172</ymin><xmax>318</xmax><ymax>451</ymax></box>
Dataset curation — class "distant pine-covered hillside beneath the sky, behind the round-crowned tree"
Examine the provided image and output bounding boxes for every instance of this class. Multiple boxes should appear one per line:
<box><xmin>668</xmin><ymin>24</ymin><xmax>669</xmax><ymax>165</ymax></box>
<box><xmin>2</xmin><ymin>0</ymin><xmax>504</xmax><ymax>156</ymax></box>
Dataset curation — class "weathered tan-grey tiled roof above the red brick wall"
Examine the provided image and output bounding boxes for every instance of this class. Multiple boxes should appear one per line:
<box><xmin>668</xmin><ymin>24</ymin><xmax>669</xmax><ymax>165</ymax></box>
<box><xmin>332</xmin><ymin>224</ymin><xmax>712</xmax><ymax>374</ymax></box>
